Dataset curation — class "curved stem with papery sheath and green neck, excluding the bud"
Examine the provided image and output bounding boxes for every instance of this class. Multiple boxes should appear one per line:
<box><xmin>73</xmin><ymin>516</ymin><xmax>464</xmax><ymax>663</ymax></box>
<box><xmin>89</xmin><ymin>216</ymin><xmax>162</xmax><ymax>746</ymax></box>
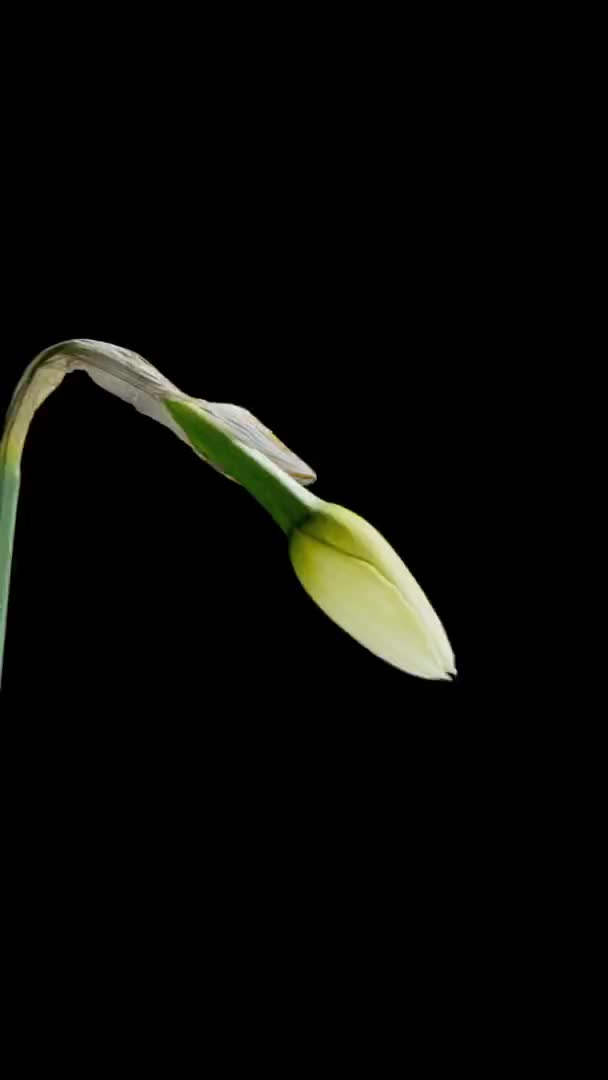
<box><xmin>0</xmin><ymin>338</ymin><xmax>317</xmax><ymax>685</ymax></box>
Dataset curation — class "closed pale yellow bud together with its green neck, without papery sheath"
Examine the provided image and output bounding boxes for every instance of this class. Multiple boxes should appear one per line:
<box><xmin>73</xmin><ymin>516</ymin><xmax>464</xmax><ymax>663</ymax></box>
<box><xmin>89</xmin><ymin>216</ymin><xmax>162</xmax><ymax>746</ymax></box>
<box><xmin>166</xmin><ymin>402</ymin><xmax>456</xmax><ymax>679</ymax></box>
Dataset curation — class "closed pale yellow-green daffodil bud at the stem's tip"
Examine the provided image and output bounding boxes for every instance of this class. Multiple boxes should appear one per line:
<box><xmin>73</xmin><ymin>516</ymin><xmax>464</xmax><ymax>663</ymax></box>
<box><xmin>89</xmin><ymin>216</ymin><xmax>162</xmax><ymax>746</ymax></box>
<box><xmin>289</xmin><ymin>503</ymin><xmax>456</xmax><ymax>679</ymax></box>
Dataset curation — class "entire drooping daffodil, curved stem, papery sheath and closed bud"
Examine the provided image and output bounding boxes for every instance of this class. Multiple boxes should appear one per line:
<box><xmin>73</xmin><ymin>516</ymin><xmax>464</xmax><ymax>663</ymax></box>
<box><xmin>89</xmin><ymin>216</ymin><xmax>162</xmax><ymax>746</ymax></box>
<box><xmin>0</xmin><ymin>339</ymin><xmax>456</xmax><ymax>679</ymax></box>
